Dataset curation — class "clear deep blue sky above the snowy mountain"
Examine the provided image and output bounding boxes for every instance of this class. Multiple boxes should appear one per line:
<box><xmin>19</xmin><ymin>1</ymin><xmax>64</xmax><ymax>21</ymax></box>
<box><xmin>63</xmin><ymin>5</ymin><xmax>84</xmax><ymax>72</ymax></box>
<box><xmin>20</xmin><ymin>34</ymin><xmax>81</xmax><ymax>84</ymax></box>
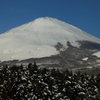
<box><xmin>0</xmin><ymin>0</ymin><xmax>100</xmax><ymax>38</ymax></box>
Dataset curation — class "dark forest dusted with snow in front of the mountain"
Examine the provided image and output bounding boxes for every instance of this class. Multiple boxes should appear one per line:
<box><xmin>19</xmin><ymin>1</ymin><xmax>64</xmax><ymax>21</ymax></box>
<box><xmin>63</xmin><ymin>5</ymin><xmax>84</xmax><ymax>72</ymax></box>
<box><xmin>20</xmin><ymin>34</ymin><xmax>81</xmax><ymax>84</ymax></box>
<box><xmin>0</xmin><ymin>62</ymin><xmax>100</xmax><ymax>100</ymax></box>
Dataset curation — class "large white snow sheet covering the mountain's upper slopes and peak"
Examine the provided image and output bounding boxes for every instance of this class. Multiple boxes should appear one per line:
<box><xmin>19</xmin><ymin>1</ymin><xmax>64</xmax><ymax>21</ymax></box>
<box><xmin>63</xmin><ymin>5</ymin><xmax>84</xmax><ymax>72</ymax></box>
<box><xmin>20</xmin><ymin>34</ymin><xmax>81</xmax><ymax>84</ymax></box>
<box><xmin>0</xmin><ymin>17</ymin><xmax>100</xmax><ymax>61</ymax></box>
